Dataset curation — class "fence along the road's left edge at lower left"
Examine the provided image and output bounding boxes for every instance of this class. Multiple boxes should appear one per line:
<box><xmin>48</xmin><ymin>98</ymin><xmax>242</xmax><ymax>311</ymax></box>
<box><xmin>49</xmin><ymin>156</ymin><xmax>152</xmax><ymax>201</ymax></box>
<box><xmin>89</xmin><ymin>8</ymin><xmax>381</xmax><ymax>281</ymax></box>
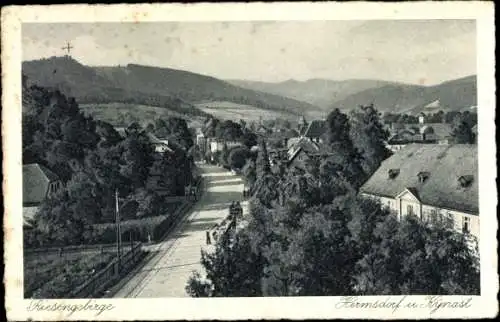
<box><xmin>65</xmin><ymin>243</ymin><xmax>144</xmax><ymax>298</ymax></box>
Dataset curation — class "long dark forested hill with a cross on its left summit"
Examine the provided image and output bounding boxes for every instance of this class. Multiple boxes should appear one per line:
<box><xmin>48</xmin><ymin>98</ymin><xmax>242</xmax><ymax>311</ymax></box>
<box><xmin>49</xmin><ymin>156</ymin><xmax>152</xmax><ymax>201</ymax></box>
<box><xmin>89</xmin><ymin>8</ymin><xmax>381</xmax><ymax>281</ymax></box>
<box><xmin>23</xmin><ymin>57</ymin><xmax>319</xmax><ymax>115</ymax></box>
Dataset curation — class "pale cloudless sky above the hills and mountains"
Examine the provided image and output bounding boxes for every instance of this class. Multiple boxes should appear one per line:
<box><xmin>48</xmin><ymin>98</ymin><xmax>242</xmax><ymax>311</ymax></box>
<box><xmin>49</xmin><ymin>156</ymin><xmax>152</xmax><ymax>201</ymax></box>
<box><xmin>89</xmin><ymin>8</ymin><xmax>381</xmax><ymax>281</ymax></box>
<box><xmin>22</xmin><ymin>20</ymin><xmax>476</xmax><ymax>85</ymax></box>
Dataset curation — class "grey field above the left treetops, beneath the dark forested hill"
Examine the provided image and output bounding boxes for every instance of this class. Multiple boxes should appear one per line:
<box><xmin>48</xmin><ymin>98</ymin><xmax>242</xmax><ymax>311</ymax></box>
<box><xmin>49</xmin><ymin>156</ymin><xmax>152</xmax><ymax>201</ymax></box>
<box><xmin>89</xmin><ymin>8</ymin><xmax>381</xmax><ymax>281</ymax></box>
<box><xmin>79</xmin><ymin>103</ymin><xmax>201</xmax><ymax>127</ymax></box>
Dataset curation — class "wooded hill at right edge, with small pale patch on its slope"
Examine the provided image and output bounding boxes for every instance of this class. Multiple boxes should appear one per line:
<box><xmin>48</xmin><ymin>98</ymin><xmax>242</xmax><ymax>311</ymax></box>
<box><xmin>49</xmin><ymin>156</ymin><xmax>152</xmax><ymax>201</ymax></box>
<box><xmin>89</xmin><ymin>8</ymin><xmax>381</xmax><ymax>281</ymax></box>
<box><xmin>332</xmin><ymin>75</ymin><xmax>477</xmax><ymax>114</ymax></box>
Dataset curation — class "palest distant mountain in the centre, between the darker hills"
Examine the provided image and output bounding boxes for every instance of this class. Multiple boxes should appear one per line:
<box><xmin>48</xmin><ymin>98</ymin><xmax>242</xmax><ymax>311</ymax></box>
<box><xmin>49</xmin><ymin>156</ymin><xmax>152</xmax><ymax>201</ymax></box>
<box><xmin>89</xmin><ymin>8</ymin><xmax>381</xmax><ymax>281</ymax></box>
<box><xmin>228</xmin><ymin>79</ymin><xmax>397</xmax><ymax>109</ymax></box>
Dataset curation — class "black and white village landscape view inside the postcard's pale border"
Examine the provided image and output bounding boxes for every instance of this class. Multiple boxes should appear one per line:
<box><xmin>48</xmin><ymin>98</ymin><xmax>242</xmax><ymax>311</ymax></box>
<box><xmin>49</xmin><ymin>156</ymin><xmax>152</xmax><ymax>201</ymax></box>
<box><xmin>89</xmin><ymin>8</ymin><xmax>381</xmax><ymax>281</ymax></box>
<box><xmin>2</xmin><ymin>1</ymin><xmax>498</xmax><ymax>317</ymax></box>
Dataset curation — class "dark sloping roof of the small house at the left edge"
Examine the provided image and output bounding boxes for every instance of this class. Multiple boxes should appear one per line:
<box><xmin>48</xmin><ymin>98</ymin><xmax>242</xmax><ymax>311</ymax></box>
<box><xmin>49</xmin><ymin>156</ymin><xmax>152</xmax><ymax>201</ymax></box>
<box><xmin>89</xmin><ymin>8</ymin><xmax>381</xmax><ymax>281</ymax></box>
<box><xmin>23</xmin><ymin>163</ymin><xmax>59</xmax><ymax>204</ymax></box>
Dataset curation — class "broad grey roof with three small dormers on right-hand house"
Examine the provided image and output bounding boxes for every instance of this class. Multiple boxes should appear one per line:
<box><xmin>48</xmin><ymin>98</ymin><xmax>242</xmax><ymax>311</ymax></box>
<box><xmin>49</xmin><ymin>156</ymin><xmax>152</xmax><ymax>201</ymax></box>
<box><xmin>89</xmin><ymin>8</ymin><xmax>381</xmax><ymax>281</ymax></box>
<box><xmin>360</xmin><ymin>144</ymin><xmax>479</xmax><ymax>214</ymax></box>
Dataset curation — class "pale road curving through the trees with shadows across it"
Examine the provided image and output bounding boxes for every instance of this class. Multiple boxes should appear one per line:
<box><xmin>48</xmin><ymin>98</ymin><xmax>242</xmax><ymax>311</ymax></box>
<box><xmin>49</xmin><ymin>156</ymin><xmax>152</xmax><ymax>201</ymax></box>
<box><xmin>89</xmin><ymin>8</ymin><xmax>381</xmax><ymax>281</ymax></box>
<box><xmin>114</xmin><ymin>164</ymin><xmax>246</xmax><ymax>298</ymax></box>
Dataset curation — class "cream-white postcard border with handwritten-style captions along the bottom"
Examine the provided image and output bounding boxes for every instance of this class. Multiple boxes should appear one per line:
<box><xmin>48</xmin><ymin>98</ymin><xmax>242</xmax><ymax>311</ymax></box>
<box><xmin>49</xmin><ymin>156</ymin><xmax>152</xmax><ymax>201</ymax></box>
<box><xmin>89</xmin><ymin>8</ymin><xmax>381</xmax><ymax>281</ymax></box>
<box><xmin>2</xmin><ymin>1</ymin><xmax>498</xmax><ymax>321</ymax></box>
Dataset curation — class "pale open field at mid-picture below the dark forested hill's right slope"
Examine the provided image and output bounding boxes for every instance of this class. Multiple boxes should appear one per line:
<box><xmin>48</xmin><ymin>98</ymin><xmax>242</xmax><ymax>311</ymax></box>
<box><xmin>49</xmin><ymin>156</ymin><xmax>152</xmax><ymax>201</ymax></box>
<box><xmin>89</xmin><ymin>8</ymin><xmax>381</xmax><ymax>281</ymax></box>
<box><xmin>195</xmin><ymin>101</ymin><xmax>297</xmax><ymax>121</ymax></box>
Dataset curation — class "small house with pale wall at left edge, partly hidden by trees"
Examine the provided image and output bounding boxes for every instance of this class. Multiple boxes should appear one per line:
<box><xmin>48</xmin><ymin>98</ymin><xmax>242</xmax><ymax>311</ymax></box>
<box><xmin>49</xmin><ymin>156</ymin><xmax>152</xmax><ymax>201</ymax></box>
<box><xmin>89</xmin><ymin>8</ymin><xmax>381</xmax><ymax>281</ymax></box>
<box><xmin>23</xmin><ymin>163</ymin><xmax>63</xmax><ymax>227</ymax></box>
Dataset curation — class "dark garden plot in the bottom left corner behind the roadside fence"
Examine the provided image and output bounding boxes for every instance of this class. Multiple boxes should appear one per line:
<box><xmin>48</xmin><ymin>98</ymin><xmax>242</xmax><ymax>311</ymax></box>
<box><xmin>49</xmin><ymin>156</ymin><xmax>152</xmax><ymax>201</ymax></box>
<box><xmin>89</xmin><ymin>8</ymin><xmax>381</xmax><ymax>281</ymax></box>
<box><xmin>24</xmin><ymin>251</ymin><xmax>115</xmax><ymax>298</ymax></box>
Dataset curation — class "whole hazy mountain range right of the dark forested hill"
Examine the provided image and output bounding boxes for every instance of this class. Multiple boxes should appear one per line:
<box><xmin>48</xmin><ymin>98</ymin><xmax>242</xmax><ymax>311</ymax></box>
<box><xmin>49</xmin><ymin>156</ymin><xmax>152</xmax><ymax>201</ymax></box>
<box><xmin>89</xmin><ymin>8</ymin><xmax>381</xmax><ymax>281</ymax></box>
<box><xmin>229</xmin><ymin>75</ymin><xmax>477</xmax><ymax>113</ymax></box>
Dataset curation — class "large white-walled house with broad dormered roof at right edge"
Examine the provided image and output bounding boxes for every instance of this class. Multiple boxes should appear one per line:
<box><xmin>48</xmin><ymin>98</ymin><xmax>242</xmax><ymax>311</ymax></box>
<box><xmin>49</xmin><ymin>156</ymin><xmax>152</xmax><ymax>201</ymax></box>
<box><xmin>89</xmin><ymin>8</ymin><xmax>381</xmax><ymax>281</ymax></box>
<box><xmin>360</xmin><ymin>144</ymin><xmax>479</xmax><ymax>239</ymax></box>
